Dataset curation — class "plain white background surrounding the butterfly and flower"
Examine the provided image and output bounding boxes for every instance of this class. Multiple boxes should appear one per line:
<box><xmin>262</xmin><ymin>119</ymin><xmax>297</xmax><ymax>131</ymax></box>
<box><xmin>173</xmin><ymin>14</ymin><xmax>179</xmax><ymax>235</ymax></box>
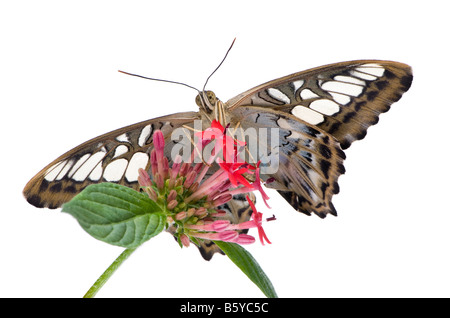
<box><xmin>0</xmin><ymin>0</ymin><xmax>450</xmax><ymax>297</ymax></box>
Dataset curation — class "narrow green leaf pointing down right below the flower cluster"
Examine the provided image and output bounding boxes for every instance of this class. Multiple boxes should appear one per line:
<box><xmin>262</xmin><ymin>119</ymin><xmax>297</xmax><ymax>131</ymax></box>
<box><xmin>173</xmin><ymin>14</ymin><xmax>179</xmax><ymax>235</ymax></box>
<box><xmin>214</xmin><ymin>241</ymin><xmax>278</xmax><ymax>298</ymax></box>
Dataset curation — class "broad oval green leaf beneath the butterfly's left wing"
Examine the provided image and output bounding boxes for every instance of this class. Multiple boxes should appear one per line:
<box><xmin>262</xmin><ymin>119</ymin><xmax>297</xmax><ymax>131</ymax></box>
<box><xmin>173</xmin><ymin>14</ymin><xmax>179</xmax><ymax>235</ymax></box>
<box><xmin>62</xmin><ymin>183</ymin><xmax>166</xmax><ymax>248</ymax></box>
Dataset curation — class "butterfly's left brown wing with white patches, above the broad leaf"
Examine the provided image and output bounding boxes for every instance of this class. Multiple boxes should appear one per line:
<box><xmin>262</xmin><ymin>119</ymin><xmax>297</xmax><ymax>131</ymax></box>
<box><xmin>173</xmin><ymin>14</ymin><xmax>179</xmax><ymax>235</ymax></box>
<box><xmin>23</xmin><ymin>112</ymin><xmax>199</xmax><ymax>208</ymax></box>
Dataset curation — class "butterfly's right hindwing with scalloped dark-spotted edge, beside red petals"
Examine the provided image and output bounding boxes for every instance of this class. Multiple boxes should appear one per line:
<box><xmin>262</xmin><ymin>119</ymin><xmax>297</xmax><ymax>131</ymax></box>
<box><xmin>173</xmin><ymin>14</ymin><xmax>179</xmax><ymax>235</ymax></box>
<box><xmin>230</xmin><ymin>106</ymin><xmax>345</xmax><ymax>217</ymax></box>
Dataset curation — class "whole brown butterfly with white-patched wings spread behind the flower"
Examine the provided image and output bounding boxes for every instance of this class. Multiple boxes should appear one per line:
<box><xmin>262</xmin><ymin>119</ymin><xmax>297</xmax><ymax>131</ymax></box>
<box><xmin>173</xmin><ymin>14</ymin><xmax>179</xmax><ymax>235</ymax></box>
<box><xmin>23</xmin><ymin>53</ymin><xmax>413</xmax><ymax>260</ymax></box>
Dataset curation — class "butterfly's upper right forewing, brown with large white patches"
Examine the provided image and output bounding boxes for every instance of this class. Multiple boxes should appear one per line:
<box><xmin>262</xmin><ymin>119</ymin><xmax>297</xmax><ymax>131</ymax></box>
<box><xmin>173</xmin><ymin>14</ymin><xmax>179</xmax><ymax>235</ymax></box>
<box><xmin>226</xmin><ymin>60</ymin><xmax>413</xmax><ymax>149</ymax></box>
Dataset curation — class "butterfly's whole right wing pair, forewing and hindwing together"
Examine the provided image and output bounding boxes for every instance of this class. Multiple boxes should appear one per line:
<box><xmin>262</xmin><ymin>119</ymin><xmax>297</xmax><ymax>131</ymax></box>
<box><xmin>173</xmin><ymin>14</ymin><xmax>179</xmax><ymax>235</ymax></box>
<box><xmin>225</xmin><ymin>60</ymin><xmax>412</xmax><ymax>217</ymax></box>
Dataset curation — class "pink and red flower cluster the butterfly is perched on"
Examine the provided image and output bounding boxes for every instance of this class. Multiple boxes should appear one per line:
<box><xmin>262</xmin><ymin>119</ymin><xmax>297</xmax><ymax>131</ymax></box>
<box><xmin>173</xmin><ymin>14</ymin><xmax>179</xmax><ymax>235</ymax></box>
<box><xmin>138</xmin><ymin>120</ymin><xmax>275</xmax><ymax>246</ymax></box>
